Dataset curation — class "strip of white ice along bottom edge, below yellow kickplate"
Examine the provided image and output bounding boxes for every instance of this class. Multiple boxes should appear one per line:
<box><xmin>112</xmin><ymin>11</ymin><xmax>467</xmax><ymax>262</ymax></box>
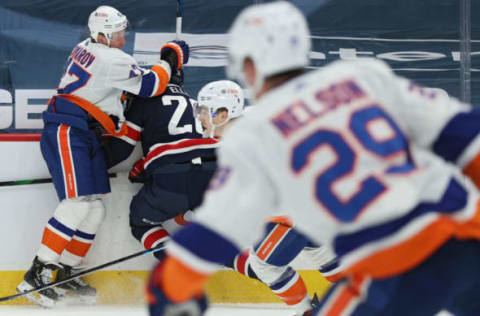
<box><xmin>0</xmin><ymin>304</ymin><xmax>452</xmax><ymax>316</ymax></box>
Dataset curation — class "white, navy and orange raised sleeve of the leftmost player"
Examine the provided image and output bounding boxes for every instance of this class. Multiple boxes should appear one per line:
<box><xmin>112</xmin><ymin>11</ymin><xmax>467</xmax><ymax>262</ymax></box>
<box><xmin>107</xmin><ymin>54</ymin><xmax>171</xmax><ymax>98</ymax></box>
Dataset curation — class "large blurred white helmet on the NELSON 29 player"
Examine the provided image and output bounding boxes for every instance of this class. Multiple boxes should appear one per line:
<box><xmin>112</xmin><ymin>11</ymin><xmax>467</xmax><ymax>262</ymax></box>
<box><xmin>227</xmin><ymin>1</ymin><xmax>311</xmax><ymax>94</ymax></box>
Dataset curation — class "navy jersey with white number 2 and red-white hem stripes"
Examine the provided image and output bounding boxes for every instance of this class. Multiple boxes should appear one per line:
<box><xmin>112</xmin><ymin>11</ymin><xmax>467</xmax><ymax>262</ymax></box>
<box><xmin>108</xmin><ymin>84</ymin><xmax>218</xmax><ymax>169</ymax></box>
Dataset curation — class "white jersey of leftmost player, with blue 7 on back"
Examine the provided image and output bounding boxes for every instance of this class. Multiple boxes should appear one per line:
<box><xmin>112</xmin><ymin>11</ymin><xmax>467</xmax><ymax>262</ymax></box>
<box><xmin>57</xmin><ymin>39</ymin><xmax>171</xmax><ymax>121</ymax></box>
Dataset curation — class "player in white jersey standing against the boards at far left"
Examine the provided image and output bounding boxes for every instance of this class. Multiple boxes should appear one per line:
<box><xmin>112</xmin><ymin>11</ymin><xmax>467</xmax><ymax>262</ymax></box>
<box><xmin>17</xmin><ymin>6</ymin><xmax>189</xmax><ymax>306</ymax></box>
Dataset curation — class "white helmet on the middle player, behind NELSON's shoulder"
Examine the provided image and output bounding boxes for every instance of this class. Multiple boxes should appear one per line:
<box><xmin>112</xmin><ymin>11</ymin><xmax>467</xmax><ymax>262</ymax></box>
<box><xmin>197</xmin><ymin>80</ymin><xmax>244</xmax><ymax>119</ymax></box>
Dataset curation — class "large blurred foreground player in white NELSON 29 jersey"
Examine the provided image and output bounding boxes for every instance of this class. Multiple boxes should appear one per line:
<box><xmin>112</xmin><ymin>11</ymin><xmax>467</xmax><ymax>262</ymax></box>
<box><xmin>148</xmin><ymin>1</ymin><xmax>480</xmax><ymax>316</ymax></box>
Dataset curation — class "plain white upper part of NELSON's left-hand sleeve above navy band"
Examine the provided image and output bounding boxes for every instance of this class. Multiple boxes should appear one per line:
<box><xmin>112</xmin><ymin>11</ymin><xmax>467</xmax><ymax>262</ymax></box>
<box><xmin>198</xmin><ymin>131</ymin><xmax>277</xmax><ymax>249</ymax></box>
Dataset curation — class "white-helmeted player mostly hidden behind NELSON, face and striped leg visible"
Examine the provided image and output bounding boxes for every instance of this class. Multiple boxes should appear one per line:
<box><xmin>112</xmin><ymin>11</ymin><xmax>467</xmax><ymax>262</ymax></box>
<box><xmin>196</xmin><ymin>80</ymin><xmax>334</xmax><ymax>315</ymax></box>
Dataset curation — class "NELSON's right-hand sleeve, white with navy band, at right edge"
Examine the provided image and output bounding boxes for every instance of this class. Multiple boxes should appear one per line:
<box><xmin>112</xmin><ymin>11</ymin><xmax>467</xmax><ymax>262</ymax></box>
<box><xmin>364</xmin><ymin>59</ymin><xmax>480</xmax><ymax>187</ymax></box>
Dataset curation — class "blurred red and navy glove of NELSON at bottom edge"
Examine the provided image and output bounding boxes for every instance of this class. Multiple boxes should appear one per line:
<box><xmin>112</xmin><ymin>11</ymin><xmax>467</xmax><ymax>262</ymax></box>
<box><xmin>147</xmin><ymin>262</ymin><xmax>208</xmax><ymax>316</ymax></box>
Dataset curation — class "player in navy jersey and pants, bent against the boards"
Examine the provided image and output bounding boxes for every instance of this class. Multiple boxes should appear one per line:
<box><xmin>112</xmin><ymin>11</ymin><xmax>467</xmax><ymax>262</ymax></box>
<box><xmin>105</xmin><ymin>71</ymin><xmax>218</xmax><ymax>256</ymax></box>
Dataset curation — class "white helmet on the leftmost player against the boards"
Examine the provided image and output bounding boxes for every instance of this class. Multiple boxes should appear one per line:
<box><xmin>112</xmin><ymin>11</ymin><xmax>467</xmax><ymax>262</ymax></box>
<box><xmin>88</xmin><ymin>5</ymin><xmax>128</xmax><ymax>46</ymax></box>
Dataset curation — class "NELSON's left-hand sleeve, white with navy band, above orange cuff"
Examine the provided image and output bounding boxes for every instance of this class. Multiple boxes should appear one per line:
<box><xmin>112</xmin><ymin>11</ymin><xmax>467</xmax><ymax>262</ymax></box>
<box><xmin>165</xmin><ymin>126</ymin><xmax>276</xmax><ymax>273</ymax></box>
